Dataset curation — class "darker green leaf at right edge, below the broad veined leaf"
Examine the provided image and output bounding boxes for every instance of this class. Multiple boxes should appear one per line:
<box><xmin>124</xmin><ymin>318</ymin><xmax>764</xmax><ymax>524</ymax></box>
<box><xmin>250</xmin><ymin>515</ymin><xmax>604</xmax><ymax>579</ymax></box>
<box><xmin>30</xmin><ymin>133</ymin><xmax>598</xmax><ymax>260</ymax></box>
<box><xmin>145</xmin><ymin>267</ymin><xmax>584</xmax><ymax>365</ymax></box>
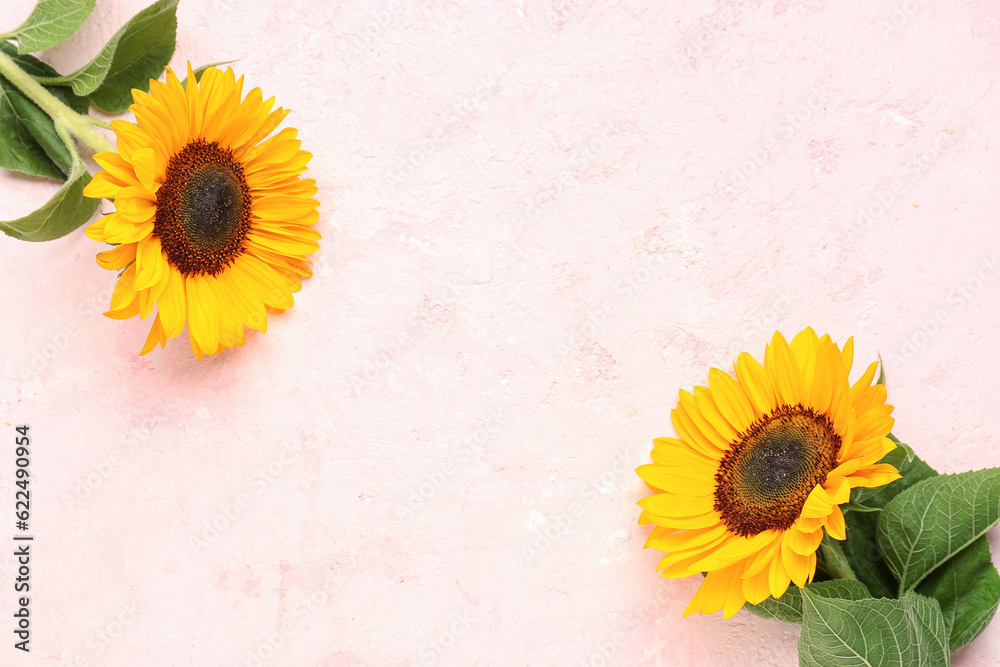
<box><xmin>917</xmin><ymin>537</ymin><xmax>1000</xmax><ymax>651</ymax></box>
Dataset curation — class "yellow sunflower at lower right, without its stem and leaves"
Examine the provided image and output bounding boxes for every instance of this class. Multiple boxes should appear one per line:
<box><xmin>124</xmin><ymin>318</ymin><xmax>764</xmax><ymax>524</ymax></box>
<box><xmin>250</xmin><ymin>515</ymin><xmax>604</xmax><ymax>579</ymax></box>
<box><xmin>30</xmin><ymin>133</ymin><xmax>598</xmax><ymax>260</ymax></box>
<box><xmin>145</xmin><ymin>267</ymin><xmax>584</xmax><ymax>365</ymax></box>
<box><xmin>636</xmin><ymin>329</ymin><xmax>900</xmax><ymax>618</ymax></box>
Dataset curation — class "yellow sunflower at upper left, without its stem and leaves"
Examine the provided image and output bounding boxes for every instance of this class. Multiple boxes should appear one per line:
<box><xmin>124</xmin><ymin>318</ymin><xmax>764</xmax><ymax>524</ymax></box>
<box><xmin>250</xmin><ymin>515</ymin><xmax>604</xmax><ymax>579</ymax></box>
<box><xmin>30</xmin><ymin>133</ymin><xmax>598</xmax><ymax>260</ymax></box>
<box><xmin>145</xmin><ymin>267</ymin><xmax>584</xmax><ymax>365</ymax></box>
<box><xmin>84</xmin><ymin>64</ymin><xmax>320</xmax><ymax>361</ymax></box>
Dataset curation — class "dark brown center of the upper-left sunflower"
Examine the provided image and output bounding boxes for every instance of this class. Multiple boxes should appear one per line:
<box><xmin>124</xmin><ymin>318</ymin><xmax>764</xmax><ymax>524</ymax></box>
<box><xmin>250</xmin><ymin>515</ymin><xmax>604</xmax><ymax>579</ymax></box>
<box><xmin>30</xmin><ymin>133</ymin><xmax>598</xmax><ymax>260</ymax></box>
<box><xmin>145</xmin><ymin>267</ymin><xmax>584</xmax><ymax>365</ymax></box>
<box><xmin>153</xmin><ymin>139</ymin><xmax>251</xmax><ymax>275</ymax></box>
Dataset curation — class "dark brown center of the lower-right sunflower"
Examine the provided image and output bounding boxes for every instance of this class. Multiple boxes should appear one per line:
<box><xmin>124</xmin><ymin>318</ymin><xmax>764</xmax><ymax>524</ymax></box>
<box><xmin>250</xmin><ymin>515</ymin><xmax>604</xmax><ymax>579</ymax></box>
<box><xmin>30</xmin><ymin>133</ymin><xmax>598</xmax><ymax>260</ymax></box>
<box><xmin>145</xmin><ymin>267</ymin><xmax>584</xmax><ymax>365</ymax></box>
<box><xmin>715</xmin><ymin>405</ymin><xmax>842</xmax><ymax>537</ymax></box>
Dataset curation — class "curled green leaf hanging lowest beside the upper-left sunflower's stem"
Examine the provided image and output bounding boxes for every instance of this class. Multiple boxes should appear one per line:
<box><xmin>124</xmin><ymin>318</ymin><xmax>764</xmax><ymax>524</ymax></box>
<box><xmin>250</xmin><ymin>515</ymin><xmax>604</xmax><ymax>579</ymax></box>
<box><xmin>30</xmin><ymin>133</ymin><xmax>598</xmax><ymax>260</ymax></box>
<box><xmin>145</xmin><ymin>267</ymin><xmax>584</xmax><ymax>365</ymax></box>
<box><xmin>0</xmin><ymin>162</ymin><xmax>101</xmax><ymax>241</ymax></box>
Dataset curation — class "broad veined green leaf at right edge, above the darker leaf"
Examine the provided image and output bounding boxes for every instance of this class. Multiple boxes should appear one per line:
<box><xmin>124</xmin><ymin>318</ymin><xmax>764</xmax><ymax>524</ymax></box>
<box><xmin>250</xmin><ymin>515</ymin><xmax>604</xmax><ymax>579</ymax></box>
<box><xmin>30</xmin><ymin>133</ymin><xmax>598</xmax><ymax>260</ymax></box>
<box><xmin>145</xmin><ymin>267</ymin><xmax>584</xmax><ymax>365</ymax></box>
<box><xmin>876</xmin><ymin>468</ymin><xmax>1000</xmax><ymax>591</ymax></box>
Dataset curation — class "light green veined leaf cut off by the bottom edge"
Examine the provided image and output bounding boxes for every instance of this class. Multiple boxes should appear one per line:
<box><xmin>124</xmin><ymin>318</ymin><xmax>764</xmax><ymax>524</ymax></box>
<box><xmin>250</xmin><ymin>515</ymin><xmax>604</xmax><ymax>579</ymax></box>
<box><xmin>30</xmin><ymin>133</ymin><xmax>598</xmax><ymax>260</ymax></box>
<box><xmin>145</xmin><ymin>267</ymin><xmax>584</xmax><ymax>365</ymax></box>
<box><xmin>799</xmin><ymin>589</ymin><xmax>951</xmax><ymax>667</ymax></box>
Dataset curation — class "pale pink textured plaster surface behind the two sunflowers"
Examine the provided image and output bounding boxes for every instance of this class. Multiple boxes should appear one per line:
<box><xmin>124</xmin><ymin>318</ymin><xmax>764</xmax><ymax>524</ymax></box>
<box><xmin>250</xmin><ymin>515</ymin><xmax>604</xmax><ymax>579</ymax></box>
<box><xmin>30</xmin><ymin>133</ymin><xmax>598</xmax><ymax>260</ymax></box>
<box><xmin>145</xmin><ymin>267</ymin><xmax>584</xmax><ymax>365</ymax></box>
<box><xmin>0</xmin><ymin>0</ymin><xmax>1000</xmax><ymax>667</ymax></box>
